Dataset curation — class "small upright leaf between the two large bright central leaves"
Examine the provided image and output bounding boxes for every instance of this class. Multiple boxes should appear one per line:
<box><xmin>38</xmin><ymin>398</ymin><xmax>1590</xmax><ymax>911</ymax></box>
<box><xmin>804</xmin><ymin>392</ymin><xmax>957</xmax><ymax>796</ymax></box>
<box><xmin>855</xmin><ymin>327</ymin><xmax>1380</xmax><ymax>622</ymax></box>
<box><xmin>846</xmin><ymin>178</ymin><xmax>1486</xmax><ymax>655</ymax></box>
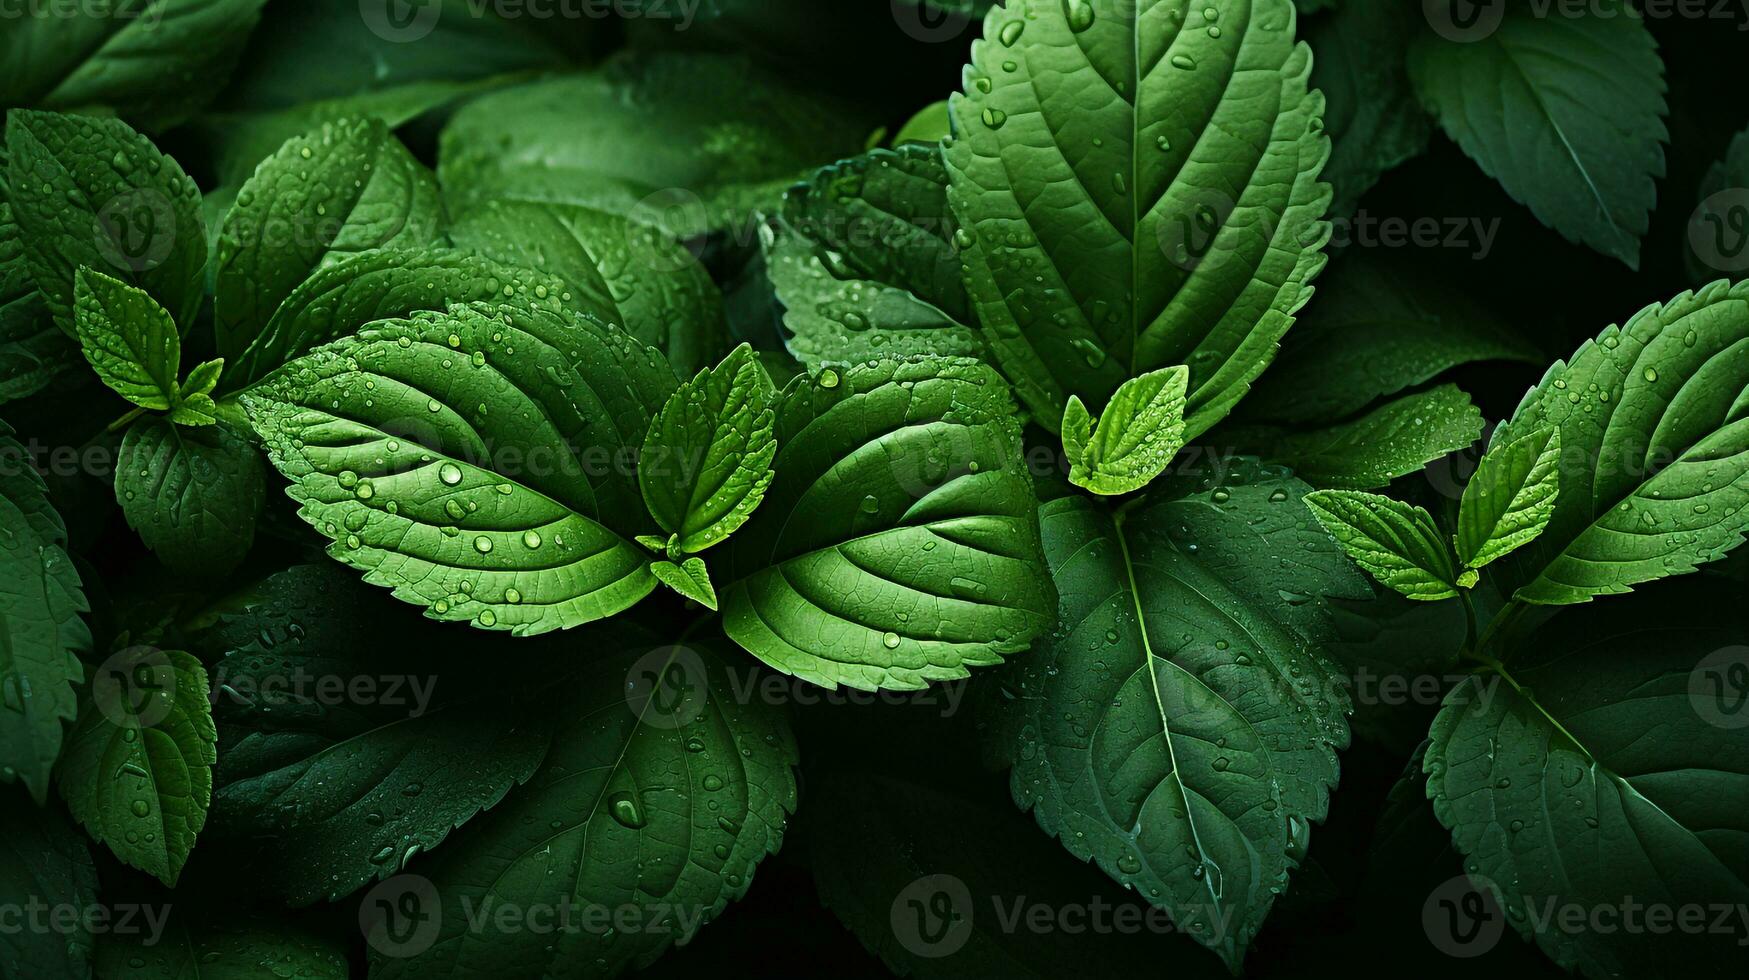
<box><xmin>638</xmin><ymin>343</ymin><xmax>777</xmax><ymax>555</ymax></box>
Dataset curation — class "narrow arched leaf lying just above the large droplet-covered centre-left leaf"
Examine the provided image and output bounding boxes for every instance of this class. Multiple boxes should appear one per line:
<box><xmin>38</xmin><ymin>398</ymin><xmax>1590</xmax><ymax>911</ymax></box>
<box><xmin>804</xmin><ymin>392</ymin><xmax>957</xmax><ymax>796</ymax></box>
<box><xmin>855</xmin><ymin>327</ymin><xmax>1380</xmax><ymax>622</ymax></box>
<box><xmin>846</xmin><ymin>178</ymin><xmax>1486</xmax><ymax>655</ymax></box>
<box><xmin>229</xmin><ymin>249</ymin><xmax>588</xmax><ymax>387</ymax></box>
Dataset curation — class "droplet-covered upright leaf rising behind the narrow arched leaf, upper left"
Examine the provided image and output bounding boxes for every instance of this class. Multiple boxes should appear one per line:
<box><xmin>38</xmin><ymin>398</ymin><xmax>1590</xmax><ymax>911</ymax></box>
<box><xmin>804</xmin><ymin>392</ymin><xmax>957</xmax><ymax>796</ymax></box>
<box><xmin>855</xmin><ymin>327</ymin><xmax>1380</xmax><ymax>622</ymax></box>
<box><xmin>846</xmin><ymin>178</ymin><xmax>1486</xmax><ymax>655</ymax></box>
<box><xmin>213</xmin><ymin>119</ymin><xmax>442</xmax><ymax>359</ymax></box>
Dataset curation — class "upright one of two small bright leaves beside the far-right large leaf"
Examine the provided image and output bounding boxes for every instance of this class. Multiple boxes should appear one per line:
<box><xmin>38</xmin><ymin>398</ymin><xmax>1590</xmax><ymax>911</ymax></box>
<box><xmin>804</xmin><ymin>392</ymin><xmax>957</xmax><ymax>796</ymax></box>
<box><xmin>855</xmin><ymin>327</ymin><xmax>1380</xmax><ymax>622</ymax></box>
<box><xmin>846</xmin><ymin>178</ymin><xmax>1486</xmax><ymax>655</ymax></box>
<box><xmin>1457</xmin><ymin>429</ymin><xmax>1560</xmax><ymax>569</ymax></box>
